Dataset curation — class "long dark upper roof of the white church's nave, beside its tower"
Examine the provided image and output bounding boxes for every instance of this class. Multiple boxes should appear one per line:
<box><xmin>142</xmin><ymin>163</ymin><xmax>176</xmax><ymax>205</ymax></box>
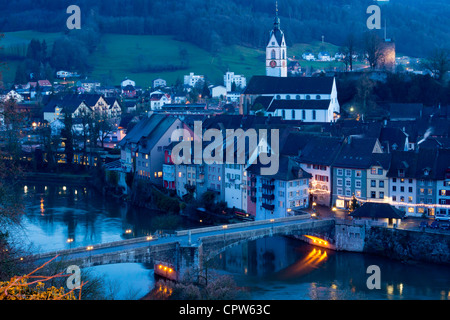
<box><xmin>244</xmin><ymin>76</ymin><xmax>334</xmax><ymax>94</ymax></box>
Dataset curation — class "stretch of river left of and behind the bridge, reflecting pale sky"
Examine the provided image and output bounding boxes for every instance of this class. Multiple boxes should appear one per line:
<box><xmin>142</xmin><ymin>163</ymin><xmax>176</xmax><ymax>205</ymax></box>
<box><xmin>17</xmin><ymin>183</ymin><xmax>197</xmax><ymax>252</ymax></box>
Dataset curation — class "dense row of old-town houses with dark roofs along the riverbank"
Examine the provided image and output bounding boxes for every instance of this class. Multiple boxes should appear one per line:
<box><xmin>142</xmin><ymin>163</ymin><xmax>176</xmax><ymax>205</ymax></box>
<box><xmin>115</xmin><ymin>99</ymin><xmax>450</xmax><ymax>219</ymax></box>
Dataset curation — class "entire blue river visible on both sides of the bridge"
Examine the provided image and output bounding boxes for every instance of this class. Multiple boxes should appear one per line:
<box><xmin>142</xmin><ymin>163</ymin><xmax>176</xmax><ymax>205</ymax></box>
<box><xmin>9</xmin><ymin>184</ymin><xmax>450</xmax><ymax>300</ymax></box>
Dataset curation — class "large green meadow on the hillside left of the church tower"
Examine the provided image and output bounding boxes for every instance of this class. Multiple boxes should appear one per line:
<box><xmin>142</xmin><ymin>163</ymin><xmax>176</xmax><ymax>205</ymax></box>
<box><xmin>92</xmin><ymin>34</ymin><xmax>264</xmax><ymax>87</ymax></box>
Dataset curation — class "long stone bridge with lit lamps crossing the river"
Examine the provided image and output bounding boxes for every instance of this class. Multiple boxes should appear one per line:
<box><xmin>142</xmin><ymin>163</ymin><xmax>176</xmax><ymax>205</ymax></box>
<box><xmin>30</xmin><ymin>215</ymin><xmax>335</xmax><ymax>280</ymax></box>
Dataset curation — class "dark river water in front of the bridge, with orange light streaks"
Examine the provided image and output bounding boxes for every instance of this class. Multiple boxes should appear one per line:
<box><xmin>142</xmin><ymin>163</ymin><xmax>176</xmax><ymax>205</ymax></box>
<box><xmin>211</xmin><ymin>237</ymin><xmax>450</xmax><ymax>300</ymax></box>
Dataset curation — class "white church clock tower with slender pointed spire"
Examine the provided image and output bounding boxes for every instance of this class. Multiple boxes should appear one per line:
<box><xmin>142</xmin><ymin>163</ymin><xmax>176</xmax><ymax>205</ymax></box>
<box><xmin>266</xmin><ymin>2</ymin><xmax>287</xmax><ymax>77</ymax></box>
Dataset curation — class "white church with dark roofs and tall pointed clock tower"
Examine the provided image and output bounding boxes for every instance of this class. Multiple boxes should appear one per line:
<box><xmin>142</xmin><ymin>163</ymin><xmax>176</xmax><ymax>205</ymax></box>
<box><xmin>239</xmin><ymin>8</ymin><xmax>340</xmax><ymax>122</ymax></box>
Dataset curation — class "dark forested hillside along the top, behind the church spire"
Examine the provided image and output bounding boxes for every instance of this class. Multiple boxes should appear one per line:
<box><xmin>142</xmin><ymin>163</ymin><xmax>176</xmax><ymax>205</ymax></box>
<box><xmin>0</xmin><ymin>0</ymin><xmax>450</xmax><ymax>56</ymax></box>
